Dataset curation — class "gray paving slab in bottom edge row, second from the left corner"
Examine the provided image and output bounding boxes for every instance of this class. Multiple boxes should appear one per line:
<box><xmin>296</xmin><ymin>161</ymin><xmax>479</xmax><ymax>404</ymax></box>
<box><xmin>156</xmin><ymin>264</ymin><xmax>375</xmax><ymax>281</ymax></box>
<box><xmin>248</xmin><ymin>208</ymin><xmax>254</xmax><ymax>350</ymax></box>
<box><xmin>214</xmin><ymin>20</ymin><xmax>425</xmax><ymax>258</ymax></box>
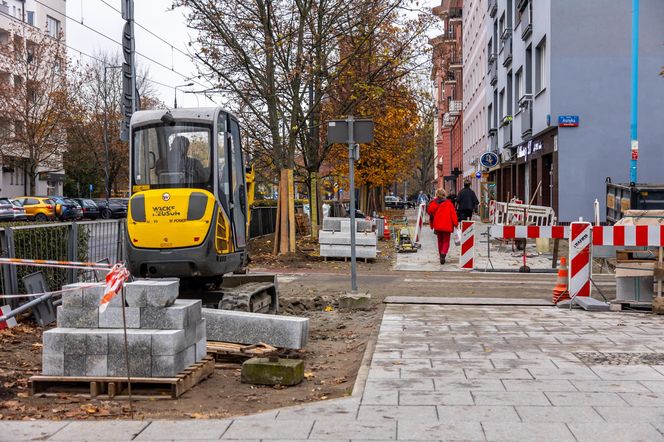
<box><xmin>49</xmin><ymin>420</ymin><xmax>149</xmax><ymax>441</ymax></box>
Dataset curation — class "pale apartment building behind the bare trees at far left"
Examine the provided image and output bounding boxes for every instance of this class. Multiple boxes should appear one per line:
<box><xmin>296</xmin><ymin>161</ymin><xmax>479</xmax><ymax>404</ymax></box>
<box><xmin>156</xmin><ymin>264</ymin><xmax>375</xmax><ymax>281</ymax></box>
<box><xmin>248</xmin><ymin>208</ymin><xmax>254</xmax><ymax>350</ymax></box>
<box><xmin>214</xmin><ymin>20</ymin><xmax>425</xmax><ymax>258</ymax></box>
<box><xmin>0</xmin><ymin>0</ymin><xmax>66</xmax><ymax>198</ymax></box>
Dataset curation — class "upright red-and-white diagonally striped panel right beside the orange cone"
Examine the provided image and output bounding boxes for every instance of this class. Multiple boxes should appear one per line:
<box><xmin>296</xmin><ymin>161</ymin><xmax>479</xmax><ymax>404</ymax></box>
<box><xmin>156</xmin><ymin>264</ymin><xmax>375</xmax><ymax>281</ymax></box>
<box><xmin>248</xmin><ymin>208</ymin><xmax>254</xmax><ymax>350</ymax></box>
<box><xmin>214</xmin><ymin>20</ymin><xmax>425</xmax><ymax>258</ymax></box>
<box><xmin>569</xmin><ymin>222</ymin><xmax>593</xmax><ymax>299</ymax></box>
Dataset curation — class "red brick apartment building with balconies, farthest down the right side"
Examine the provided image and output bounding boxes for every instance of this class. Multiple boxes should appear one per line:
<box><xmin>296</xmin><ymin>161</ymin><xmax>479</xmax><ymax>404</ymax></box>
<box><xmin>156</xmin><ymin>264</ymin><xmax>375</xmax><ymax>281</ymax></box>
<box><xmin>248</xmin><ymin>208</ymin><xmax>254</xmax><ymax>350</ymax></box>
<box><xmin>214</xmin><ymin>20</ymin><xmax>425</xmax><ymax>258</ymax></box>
<box><xmin>429</xmin><ymin>0</ymin><xmax>464</xmax><ymax>193</ymax></box>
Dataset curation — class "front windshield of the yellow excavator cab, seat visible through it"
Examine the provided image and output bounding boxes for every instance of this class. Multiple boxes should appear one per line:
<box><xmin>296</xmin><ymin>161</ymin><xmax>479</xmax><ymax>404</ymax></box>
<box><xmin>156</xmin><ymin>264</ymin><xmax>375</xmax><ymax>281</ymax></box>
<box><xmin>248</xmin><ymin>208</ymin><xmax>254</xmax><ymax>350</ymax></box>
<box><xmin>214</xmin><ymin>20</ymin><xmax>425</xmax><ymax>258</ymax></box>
<box><xmin>132</xmin><ymin>123</ymin><xmax>212</xmax><ymax>190</ymax></box>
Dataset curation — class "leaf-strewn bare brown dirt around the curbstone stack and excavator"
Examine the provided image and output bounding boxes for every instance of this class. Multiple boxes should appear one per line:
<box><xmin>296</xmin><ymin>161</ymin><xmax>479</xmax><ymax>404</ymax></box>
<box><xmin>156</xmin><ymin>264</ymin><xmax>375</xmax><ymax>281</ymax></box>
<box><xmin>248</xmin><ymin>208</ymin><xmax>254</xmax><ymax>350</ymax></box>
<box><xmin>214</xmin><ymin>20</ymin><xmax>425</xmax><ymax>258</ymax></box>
<box><xmin>0</xmin><ymin>233</ymin><xmax>394</xmax><ymax>420</ymax></box>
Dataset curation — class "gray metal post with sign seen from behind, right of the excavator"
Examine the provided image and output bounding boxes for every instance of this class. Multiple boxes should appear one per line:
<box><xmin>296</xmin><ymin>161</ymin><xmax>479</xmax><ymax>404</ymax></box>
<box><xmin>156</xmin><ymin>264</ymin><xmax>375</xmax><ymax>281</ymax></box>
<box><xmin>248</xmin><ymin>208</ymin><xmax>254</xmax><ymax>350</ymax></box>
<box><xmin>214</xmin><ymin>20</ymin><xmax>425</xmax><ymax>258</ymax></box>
<box><xmin>327</xmin><ymin>115</ymin><xmax>374</xmax><ymax>294</ymax></box>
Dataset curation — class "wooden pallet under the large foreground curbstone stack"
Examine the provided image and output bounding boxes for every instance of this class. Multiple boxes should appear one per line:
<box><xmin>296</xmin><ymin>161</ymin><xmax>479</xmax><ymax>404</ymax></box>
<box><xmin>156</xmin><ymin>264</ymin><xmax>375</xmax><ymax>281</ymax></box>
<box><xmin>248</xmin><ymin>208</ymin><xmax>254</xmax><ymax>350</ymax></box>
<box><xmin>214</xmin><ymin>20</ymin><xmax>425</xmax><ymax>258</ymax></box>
<box><xmin>29</xmin><ymin>356</ymin><xmax>214</xmax><ymax>400</ymax></box>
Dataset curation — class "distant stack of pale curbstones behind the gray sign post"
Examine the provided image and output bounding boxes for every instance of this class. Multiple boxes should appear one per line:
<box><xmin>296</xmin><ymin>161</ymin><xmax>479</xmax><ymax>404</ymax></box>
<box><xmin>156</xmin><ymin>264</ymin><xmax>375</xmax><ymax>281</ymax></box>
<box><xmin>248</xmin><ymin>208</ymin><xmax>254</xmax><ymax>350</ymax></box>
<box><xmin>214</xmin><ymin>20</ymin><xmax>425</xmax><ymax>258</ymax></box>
<box><xmin>318</xmin><ymin>218</ymin><xmax>378</xmax><ymax>259</ymax></box>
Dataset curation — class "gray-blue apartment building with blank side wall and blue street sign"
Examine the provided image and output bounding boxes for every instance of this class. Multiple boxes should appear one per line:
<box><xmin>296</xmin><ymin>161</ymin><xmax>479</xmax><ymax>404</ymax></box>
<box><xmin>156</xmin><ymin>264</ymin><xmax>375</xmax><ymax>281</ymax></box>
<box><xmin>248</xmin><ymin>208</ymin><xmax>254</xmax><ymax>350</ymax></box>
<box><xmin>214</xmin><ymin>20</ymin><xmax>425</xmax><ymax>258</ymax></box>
<box><xmin>486</xmin><ymin>0</ymin><xmax>664</xmax><ymax>221</ymax></box>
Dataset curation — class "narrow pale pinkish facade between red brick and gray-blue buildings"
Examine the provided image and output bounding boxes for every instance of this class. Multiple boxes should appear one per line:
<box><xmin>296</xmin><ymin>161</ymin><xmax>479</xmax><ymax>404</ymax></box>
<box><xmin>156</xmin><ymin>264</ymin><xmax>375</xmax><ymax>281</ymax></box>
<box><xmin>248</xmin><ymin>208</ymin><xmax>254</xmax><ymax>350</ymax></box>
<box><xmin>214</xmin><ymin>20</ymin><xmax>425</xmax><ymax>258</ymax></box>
<box><xmin>463</xmin><ymin>0</ymin><xmax>488</xmax><ymax>195</ymax></box>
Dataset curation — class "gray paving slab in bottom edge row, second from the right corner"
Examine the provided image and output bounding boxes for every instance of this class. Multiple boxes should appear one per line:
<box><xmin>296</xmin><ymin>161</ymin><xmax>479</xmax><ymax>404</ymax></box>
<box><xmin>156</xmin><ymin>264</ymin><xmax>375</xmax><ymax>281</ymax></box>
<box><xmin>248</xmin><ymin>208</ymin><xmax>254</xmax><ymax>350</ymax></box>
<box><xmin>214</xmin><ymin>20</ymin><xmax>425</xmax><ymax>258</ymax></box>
<box><xmin>482</xmin><ymin>422</ymin><xmax>575</xmax><ymax>442</ymax></box>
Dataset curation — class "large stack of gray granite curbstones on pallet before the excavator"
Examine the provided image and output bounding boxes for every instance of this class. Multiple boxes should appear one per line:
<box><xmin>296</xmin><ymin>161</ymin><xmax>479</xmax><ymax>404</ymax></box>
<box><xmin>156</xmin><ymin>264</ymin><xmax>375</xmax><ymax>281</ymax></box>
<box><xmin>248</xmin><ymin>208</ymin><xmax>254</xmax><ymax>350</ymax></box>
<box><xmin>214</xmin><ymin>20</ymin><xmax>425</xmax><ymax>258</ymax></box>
<box><xmin>42</xmin><ymin>279</ymin><xmax>207</xmax><ymax>377</ymax></box>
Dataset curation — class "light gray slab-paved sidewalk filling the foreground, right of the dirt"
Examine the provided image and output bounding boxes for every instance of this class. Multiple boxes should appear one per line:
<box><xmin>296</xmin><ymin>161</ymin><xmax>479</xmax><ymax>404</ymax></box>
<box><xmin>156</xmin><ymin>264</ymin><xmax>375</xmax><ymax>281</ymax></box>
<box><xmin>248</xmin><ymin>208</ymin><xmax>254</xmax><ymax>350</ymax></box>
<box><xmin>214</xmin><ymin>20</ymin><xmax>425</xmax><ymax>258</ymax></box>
<box><xmin>7</xmin><ymin>300</ymin><xmax>664</xmax><ymax>442</ymax></box>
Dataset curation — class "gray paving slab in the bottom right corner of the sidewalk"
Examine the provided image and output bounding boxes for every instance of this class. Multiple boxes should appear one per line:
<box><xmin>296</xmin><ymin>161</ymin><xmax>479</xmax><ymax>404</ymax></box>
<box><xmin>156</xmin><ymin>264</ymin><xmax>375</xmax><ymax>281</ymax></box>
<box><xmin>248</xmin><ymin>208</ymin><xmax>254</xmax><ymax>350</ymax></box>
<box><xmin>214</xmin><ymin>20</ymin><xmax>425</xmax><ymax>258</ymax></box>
<box><xmin>569</xmin><ymin>422</ymin><xmax>664</xmax><ymax>442</ymax></box>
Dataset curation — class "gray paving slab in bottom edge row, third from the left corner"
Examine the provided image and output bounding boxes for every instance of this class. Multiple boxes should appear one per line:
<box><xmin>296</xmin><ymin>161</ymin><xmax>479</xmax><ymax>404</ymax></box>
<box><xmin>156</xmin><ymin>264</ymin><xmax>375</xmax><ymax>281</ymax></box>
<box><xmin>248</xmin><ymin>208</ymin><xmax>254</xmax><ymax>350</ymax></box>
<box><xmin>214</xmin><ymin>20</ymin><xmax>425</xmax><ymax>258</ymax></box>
<box><xmin>134</xmin><ymin>420</ymin><xmax>231</xmax><ymax>441</ymax></box>
